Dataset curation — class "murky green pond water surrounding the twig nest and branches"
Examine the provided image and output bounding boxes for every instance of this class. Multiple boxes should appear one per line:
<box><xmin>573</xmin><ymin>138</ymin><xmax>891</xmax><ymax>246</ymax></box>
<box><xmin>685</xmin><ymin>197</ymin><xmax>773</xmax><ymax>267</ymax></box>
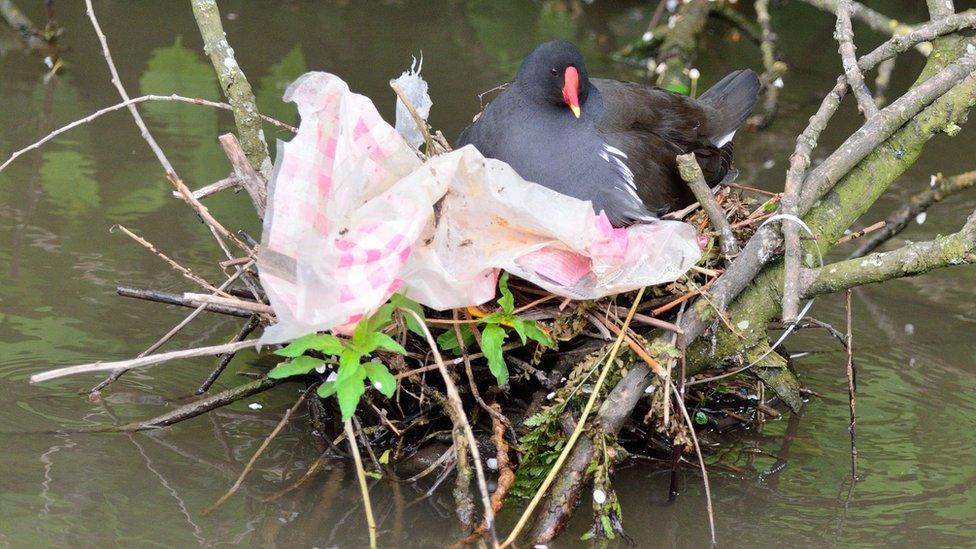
<box><xmin>0</xmin><ymin>0</ymin><xmax>976</xmax><ymax>547</ymax></box>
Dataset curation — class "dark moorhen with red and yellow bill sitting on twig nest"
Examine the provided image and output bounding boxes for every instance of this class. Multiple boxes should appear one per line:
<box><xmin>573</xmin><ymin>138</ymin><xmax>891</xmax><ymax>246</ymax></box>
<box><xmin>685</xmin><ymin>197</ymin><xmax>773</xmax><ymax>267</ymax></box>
<box><xmin>457</xmin><ymin>40</ymin><xmax>760</xmax><ymax>227</ymax></box>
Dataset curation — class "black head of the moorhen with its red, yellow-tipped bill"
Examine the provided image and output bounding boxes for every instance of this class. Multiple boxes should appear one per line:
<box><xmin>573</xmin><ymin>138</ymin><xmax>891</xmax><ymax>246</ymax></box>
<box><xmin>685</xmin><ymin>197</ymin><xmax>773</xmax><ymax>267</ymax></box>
<box><xmin>515</xmin><ymin>40</ymin><xmax>590</xmax><ymax>117</ymax></box>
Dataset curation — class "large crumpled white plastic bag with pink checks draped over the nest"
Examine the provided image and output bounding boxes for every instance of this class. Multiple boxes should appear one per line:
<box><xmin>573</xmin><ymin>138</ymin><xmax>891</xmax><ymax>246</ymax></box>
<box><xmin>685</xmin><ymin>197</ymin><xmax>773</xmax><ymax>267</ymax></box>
<box><xmin>257</xmin><ymin>72</ymin><xmax>701</xmax><ymax>343</ymax></box>
